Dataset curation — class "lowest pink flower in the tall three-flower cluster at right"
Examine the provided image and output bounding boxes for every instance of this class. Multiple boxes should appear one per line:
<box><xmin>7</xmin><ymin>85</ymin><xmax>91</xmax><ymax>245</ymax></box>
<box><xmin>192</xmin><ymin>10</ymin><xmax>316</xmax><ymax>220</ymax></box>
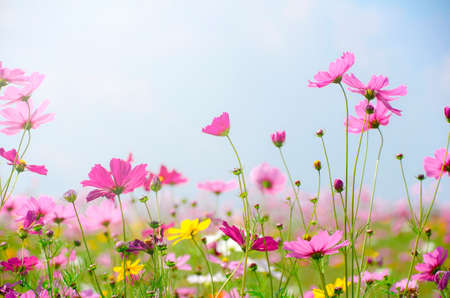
<box><xmin>344</xmin><ymin>100</ymin><xmax>392</xmax><ymax>133</ymax></box>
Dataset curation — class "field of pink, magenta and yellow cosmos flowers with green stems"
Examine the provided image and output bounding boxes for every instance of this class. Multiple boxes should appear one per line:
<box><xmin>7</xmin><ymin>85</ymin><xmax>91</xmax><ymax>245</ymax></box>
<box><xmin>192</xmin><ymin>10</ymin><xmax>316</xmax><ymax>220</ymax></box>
<box><xmin>0</xmin><ymin>52</ymin><xmax>450</xmax><ymax>298</ymax></box>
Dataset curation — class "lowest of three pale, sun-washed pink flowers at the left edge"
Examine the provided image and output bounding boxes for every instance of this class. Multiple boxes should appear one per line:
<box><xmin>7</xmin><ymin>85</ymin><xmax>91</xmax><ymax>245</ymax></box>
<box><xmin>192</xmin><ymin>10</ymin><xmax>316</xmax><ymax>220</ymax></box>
<box><xmin>0</xmin><ymin>100</ymin><xmax>55</xmax><ymax>135</ymax></box>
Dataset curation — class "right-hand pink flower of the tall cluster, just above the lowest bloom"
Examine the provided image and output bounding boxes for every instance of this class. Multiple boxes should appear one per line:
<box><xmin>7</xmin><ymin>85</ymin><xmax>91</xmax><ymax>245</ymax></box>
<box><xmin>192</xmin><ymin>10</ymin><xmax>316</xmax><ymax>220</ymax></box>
<box><xmin>344</xmin><ymin>74</ymin><xmax>408</xmax><ymax>116</ymax></box>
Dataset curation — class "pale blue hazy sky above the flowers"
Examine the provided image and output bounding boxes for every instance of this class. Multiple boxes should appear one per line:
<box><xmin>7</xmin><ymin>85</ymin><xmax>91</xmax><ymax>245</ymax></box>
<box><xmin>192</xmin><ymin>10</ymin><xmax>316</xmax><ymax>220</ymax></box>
<box><xmin>0</xmin><ymin>0</ymin><xmax>450</xmax><ymax>204</ymax></box>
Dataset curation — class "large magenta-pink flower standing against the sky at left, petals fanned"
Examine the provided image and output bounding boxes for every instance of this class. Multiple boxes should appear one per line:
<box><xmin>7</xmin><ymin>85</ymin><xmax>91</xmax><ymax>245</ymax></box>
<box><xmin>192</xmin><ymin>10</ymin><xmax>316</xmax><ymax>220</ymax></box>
<box><xmin>81</xmin><ymin>158</ymin><xmax>147</xmax><ymax>202</ymax></box>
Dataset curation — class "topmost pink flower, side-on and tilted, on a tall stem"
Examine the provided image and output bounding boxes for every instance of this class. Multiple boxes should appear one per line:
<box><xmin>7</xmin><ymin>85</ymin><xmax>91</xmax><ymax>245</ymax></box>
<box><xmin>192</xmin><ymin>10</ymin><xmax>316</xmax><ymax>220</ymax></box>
<box><xmin>308</xmin><ymin>52</ymin><xmax>355</xmax><ymax>88</ymax></box>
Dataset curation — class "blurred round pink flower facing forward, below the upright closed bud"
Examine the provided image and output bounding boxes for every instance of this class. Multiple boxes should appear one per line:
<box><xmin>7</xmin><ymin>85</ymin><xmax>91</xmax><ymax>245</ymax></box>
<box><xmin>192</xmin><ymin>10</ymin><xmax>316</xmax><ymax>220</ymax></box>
<box><xmin>250</xmin><ymin>163</ymin><xmax>286</xmax><ymax>194</ymax></box>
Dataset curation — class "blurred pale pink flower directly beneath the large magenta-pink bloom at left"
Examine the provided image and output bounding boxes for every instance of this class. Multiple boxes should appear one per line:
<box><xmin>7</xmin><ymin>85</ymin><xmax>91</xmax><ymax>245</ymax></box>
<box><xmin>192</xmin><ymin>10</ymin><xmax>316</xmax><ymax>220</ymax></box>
<box><xmin>83</xmin><ymin>200</ymin><xmax>122</xmax><ymax>231</ymax></box>
